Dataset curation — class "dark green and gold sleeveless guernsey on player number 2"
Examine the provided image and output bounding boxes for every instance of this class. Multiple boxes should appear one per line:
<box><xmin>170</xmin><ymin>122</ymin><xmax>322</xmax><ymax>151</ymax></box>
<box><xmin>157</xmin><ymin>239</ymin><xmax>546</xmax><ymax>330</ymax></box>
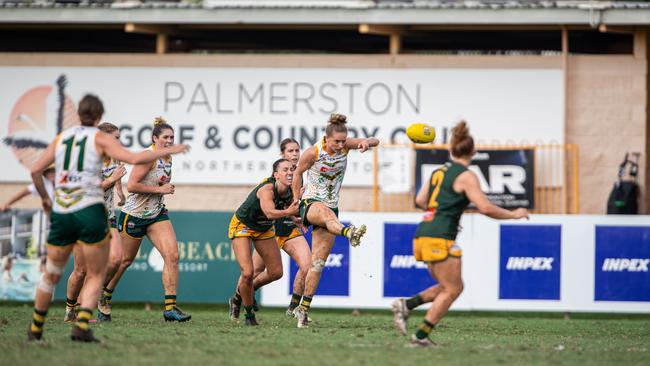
<box><xmin>415</xmin><ymin>162</ymin><xmax>469</xmax><ymax>240</ymax></box>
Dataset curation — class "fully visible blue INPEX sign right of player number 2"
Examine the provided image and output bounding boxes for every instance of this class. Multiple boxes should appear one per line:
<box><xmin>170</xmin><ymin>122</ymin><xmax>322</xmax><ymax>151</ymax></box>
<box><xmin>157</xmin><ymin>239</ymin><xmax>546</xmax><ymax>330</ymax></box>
<box><xmin>499</xmin><ymin>225</ymin><xmax>562</xmax><ymax>300</ymax></box>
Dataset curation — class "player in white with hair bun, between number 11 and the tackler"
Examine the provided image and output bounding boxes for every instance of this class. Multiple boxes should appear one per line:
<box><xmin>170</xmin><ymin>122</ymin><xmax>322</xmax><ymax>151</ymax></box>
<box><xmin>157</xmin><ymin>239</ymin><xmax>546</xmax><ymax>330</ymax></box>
<box><xmin>108</xmin><ymin>118</ymin><xmax>192</xmax><ymax>322</ymax></box>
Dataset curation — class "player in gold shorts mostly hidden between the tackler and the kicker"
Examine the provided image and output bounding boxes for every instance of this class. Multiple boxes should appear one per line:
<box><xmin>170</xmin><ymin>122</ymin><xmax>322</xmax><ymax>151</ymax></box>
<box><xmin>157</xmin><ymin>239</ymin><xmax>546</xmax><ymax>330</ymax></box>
<box><xmin>229</xmin><ymin>138</ymin><xmax>311</xmax><ymax>318</ymax></box>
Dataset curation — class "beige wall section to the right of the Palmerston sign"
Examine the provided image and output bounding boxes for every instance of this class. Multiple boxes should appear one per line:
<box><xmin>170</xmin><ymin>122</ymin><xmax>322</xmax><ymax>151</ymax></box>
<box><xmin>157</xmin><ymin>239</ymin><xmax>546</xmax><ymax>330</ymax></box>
<box><xmin>566</xmin><ymin>56</ymin><xmax>648</xmax><ymax>214</ymax></box>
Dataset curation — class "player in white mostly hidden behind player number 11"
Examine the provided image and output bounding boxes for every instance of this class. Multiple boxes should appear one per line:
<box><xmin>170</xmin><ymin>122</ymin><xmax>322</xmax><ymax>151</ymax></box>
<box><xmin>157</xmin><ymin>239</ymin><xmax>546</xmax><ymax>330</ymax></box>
<box><xmin>63</xmin><ymin>122</ymin><xmax>126</xmax><ymax>322</ymax></box>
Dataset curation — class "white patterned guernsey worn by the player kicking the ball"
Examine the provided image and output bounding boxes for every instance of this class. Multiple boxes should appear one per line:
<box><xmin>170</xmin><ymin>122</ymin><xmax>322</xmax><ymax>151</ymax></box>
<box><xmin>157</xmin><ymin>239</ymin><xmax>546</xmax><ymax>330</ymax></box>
<box><xmin>302</xmin><ymin>137</ymin><xmax>348</xmax><ymax>208</ymax></box>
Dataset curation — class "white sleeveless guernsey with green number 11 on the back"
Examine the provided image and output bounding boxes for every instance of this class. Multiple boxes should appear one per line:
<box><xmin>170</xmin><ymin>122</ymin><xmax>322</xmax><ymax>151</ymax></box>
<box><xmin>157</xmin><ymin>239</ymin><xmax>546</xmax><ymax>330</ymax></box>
<box><xmin>52</xmin><ymin>126</ymin><xmax>104</xmax><ymax>214</ymax></box>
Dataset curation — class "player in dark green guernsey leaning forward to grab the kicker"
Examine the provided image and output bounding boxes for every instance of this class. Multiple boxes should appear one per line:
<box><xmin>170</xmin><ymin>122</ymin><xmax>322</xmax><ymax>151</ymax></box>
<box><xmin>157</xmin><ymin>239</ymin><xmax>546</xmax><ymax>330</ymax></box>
<box><xmin>228</xmin><ymin>159</ymin><xmax>298</xmax><ymax>325</ymax></box>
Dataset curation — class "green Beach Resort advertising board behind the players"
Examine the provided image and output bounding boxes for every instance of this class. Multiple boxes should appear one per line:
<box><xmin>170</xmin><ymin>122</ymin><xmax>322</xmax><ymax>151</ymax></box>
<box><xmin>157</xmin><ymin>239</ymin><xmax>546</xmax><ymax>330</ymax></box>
<box><xmin>55</xmin><ymin>211</ymin><xmax>239</xmax><ymax>304</ymax></box>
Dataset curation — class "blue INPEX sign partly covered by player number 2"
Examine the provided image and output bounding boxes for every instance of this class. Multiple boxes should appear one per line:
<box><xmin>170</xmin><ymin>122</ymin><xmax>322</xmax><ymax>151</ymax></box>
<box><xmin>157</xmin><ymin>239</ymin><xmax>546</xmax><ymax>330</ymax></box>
<box><xmin>384</xmin><ymin>223</ymin><xmax>436</xmax><ymax>297</ymax></box>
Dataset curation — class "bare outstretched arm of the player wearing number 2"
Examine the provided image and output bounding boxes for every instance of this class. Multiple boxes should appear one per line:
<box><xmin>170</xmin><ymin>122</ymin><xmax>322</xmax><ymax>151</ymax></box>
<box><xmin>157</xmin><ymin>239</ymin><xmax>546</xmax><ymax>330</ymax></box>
<box><xmin>454</xmin><ymin>170</ymin><xmax>528</xmax><ymax>220</ymax></box>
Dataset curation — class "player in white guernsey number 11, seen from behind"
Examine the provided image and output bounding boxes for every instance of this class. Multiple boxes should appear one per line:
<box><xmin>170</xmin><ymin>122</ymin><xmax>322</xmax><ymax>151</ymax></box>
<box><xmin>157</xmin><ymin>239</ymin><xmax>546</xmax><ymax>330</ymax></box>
<box><xmin>27</xmin><ymin>95</ymin><xmax>188</xmax><ymax>342</ymax></box>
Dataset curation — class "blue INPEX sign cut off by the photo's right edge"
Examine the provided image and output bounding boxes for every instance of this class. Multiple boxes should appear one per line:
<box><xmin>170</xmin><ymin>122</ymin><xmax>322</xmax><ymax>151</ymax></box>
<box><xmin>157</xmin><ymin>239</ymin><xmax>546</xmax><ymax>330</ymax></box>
<box><xmin>594</xmin><ymin>226</ymin><xmax>650</xmax><ymax>301</ymax></box>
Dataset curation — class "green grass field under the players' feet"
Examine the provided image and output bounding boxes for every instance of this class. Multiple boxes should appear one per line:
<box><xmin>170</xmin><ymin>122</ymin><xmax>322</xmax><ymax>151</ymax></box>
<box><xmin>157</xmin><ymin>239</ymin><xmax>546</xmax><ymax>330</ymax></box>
<box><xmin>0</xmin><ymin>303</ymin><xmax>650</xmax><ymax>366</ymax></box>
